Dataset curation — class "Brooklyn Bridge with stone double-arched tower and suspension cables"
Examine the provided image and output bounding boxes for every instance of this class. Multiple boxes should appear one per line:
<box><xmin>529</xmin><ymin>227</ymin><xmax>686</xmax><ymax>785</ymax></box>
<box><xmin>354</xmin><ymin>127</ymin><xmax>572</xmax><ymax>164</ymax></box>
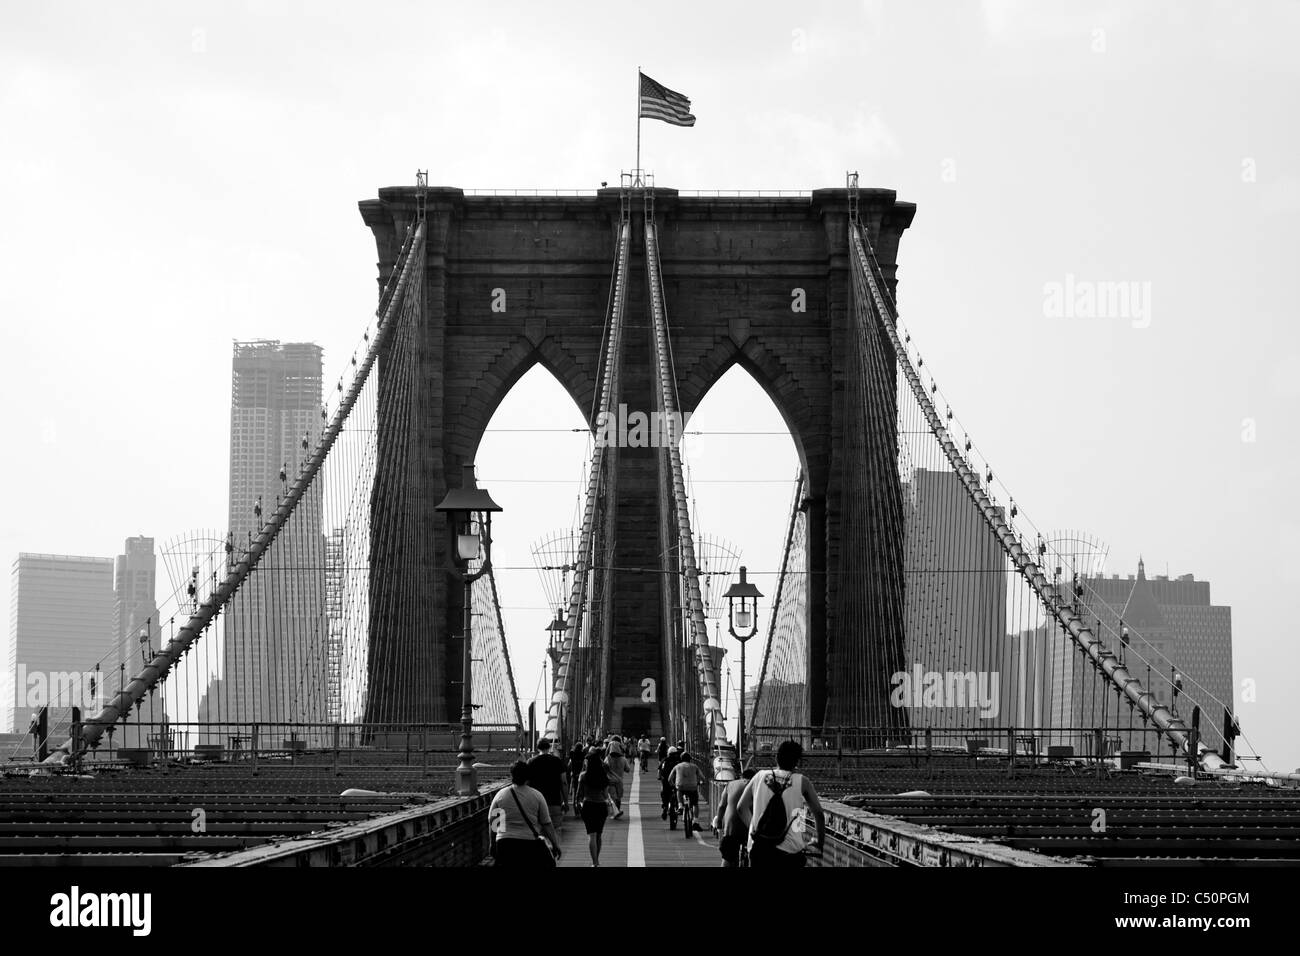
<box><xmin>0</xmin><ymin>170</ymin><xmax>1300</xmax><ymax>868</ymax></box>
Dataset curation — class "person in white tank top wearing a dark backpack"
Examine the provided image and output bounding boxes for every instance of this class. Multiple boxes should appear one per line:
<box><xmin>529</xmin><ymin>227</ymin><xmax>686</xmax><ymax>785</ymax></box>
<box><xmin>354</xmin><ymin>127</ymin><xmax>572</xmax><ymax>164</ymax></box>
<box><xmin>737</xmin><ymin>740</ymin><xmax>826</xmax><ymax>868</ymax></box>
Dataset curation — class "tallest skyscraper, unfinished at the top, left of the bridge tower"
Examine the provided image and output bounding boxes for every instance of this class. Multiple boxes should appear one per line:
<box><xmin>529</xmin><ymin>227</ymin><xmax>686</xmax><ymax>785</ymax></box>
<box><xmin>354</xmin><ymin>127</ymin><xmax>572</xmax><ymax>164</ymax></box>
<box><xmin>222</xmin><ymin>341</ymin><xmax>329</xmax><ymax>722</ymax></box>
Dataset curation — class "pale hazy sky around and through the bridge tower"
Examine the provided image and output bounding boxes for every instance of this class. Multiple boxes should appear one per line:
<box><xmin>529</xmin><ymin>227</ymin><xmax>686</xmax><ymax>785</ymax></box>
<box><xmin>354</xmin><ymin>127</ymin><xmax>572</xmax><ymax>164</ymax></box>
<box><xmin>0</xmin><ymin>0</ymin><xmax>1300</xmax><ymax>770</ymax></box>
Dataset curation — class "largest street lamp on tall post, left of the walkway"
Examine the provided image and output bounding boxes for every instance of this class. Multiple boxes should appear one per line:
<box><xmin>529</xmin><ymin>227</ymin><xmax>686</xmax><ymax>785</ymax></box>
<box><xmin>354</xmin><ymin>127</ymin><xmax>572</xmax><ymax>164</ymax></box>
<box><xmin>434</xmin><ymin>462</ymin><xmax>502</xmax><ymax>796</ymax></box>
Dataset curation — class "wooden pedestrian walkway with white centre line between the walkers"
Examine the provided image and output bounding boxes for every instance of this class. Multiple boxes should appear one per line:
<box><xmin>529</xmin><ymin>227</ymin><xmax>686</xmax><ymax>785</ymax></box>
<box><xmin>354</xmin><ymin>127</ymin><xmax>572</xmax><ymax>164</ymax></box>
<box><xmin>560</xmin><ymin>758</ymin><xmax>722</xmax><ymax>866</ymax></box>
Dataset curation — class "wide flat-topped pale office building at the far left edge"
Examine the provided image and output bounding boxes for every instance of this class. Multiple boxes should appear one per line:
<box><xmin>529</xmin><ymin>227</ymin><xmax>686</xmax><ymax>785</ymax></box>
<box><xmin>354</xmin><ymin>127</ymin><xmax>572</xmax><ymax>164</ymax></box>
<box><xmin>0</xmin><ymin>553</ymin><xmax>117</xmax><ymax>734</ymax></box>
